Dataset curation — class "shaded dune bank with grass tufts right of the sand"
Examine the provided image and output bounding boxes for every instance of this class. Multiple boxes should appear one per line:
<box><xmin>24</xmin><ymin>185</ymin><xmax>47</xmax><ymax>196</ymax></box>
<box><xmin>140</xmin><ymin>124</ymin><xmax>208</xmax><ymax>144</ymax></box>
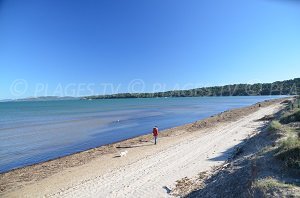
<box><xmin>182</xmin><ymin>97</ymin><xmax>300</xmax><ymax>197</ymax></box>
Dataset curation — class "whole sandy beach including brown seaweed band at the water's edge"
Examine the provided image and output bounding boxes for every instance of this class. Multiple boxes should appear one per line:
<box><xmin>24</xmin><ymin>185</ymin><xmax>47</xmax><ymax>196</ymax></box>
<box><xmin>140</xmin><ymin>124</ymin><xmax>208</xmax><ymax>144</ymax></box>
<box><xmin>0</xmin><ymin>99</ymin><xmax>284</xmax><ymax>197</ymax></box>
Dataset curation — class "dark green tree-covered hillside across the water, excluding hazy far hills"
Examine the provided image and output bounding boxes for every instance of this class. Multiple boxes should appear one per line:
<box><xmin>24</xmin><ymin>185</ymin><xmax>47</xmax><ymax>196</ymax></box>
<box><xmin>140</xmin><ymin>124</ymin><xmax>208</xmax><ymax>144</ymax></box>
<box><xmin>82</xmin><ymin>78</ymin><xmax>300</xmax><ymax>99</ymax></box>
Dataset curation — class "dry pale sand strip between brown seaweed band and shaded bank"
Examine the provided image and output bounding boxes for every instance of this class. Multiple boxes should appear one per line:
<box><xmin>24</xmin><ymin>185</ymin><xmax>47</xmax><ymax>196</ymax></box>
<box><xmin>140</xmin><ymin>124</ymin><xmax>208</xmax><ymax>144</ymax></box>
<box><xmin>3</xmin><ymin>101</ymin><xmax>282</xmax><ymax>197</ymax></box>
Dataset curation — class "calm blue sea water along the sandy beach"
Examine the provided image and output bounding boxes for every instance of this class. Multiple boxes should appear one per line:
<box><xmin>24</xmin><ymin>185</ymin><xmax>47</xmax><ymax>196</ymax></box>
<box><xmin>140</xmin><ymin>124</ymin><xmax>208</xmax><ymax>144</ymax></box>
<box><xmin>0</xmin><ymin>96</ymin><xmax>279</xmax><ymax>172</ymax></box>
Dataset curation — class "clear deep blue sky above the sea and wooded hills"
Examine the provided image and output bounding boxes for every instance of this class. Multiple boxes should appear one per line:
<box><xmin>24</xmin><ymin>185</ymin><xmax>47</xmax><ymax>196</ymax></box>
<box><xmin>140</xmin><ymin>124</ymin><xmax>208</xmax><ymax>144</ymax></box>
<box><xmin>0</xmin><ymin>0</ymin><xmax>300</xmax><ymax>99</ymax></box>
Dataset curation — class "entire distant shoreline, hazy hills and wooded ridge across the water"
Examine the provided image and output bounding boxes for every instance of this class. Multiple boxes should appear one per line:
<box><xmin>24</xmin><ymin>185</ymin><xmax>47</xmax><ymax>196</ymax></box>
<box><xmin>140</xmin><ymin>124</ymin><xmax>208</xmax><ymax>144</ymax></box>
<box><xmin>0</xmin><ymin>78</ymin><xmax>300</xmax><ymax>102</ymax></box>
